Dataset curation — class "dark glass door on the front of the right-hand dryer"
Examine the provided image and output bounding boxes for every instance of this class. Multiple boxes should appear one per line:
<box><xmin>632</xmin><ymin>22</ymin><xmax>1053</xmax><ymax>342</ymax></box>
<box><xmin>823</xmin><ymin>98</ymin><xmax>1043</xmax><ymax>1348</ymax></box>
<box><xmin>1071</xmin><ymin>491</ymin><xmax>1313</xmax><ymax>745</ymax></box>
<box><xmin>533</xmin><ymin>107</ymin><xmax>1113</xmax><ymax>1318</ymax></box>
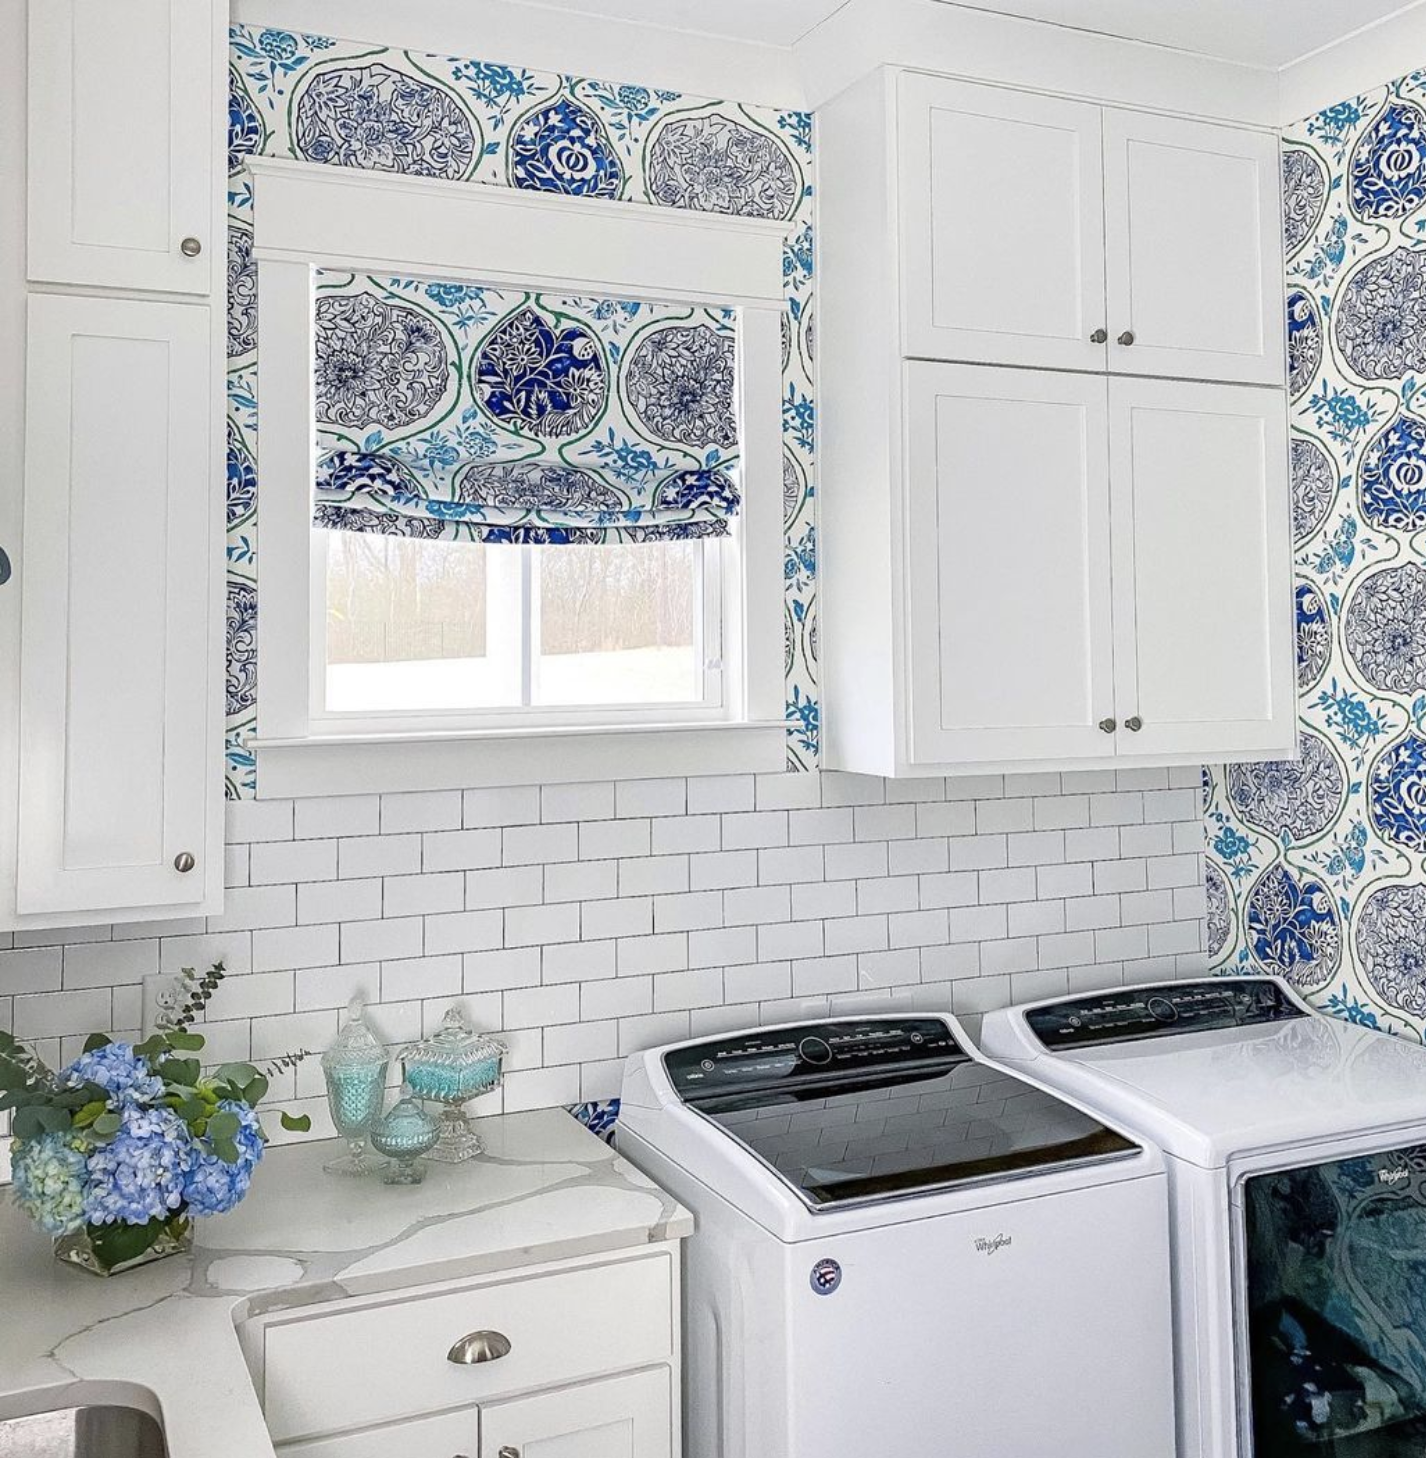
<box><xmin>1244</xmin><ymin>1145</ymin><xmax>1426</xmax><ymax>1458</ymax></box>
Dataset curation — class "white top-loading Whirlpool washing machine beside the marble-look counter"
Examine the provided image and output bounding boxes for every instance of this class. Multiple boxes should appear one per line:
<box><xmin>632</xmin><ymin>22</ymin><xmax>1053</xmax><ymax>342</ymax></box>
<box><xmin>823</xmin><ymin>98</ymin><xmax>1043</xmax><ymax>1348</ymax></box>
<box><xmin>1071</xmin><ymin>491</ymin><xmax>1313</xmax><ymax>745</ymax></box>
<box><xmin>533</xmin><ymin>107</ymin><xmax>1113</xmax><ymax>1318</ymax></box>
<box><xmin>618</xmin><ymin>1016</ymin><xmax>1174</xmax><ymax>1458</ymax></box>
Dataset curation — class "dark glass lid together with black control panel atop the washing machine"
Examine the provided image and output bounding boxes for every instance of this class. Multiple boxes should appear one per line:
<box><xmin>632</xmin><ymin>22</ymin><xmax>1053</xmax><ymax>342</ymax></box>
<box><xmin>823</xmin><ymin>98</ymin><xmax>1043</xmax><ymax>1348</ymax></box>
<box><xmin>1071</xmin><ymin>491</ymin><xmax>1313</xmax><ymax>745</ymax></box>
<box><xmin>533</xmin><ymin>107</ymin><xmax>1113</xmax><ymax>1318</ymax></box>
<box><xmin>663</xmin><ymin>1018</ymin><xmax>1139</xmax><ymax>1212</ymax></box>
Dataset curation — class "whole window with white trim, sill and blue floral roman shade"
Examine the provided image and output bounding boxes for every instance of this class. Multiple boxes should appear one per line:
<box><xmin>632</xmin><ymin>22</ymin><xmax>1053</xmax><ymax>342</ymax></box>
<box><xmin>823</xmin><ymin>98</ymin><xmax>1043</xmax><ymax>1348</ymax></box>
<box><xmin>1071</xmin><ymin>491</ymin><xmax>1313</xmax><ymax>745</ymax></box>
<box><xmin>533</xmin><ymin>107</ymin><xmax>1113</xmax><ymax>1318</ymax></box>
<box><xmin>249</xmin><ymin>157</ymin><xmax>786</xmax><ymax>796</ymax></box>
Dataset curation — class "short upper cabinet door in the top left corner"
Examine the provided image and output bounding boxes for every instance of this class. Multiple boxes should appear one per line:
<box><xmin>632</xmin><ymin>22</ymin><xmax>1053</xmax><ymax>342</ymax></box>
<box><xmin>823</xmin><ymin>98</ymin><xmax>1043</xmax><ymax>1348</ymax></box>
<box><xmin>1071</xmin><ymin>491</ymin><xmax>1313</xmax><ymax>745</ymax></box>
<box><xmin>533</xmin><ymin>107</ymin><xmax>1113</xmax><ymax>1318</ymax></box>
<box><xmin>29</xmin><ymin>0</ymin><xmax>217</xmax><ymax>295</ymax></box>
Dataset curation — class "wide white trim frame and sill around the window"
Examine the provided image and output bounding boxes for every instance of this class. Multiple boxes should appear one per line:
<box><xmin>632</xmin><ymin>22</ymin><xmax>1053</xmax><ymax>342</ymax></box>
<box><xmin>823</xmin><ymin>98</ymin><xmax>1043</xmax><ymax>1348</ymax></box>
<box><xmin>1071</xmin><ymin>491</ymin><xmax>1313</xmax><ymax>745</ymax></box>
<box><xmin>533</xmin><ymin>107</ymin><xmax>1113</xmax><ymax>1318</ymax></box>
<box><xmin>239</xmin><ymin>157</ymin><xmax>789</xmax><ymax>798</ymax></box>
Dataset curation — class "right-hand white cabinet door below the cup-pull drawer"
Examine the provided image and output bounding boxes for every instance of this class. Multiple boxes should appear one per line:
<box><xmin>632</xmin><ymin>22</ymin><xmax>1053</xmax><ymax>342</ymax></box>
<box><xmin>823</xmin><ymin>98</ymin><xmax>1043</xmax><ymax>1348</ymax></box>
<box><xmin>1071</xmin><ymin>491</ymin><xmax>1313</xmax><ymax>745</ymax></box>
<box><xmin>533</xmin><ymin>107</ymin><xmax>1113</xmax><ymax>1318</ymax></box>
<box><xmin>480</xmin><ymin>1368</ymin><xmax>674</xmax><ymax>1458</ymax></box>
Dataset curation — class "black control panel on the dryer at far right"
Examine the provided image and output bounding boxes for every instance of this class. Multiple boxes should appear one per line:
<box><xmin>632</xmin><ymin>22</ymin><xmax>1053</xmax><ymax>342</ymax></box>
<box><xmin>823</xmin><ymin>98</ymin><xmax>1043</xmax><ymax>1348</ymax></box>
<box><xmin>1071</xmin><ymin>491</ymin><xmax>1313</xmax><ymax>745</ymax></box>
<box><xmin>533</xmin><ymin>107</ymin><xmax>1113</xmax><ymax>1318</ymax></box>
<box><xmin>1025</xmin><ymin>977</ymin><xmax>1306</xmax><ymax>1051</ymax></box>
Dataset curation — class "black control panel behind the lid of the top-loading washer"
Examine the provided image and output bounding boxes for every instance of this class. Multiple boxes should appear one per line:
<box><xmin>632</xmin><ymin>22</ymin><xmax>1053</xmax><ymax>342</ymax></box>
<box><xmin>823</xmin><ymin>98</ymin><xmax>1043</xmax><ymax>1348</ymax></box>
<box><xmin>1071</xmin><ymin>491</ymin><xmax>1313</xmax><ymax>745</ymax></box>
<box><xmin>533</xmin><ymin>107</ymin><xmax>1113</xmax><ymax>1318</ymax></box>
<box><xmin>663</xmin><ymin>1018</ymin><xmax>965</xmax><ymax>1102</ymax></box>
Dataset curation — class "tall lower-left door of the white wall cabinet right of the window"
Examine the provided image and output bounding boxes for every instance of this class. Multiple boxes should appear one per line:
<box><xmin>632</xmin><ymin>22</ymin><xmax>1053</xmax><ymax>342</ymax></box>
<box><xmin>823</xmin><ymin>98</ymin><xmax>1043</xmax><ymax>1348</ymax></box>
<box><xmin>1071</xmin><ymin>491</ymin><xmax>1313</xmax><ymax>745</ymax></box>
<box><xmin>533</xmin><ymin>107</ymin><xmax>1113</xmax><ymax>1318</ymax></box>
<box><xmin>903</xmin><ymin>365</ymin><xmax>1114</xmax><ymax>765</ymax></box>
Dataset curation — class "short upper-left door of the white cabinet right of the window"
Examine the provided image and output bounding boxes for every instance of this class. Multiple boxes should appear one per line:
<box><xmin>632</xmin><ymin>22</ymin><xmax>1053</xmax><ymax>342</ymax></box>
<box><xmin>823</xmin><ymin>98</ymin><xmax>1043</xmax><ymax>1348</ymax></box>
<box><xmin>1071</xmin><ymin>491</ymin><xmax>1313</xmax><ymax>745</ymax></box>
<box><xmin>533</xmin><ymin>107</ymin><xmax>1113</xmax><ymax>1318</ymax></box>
<box><xmin>898</xmin><ymin>74</ymin><xmax>1107</xmax><ymax>369</ymax></box>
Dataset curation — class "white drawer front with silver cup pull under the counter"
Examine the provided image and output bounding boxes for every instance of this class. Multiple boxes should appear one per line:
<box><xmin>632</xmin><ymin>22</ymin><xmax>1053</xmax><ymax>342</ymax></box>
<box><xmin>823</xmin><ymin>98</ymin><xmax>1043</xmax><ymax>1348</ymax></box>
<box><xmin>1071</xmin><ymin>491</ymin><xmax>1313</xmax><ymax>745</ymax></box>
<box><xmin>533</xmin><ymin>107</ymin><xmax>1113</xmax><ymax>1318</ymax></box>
<box><xmin>262</xmin><ymin>1254</ymin><xmax>674</xmax><ymax>1442</ymax></box>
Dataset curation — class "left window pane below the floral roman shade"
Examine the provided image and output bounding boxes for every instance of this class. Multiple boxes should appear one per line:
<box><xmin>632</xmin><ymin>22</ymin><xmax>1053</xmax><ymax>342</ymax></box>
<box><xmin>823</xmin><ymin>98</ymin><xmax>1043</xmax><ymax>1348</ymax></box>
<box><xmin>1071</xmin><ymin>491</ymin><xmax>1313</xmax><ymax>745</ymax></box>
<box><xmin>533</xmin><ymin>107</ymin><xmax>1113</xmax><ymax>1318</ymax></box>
<box><xmin>324</xmin><ymin>532</ymin><xmax>519</xmax><ymax>713</ymax></box>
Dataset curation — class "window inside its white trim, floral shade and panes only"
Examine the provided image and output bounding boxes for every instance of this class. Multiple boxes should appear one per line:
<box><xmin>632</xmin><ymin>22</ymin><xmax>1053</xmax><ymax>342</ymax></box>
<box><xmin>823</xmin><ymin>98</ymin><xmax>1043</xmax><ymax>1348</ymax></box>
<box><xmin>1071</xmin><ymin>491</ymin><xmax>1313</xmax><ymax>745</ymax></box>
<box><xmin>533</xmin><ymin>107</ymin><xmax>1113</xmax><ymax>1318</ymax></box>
<box><xmin>311</xmin><ymin>271</ymin><xmax>739</xmax><ymax>730</ymax></box>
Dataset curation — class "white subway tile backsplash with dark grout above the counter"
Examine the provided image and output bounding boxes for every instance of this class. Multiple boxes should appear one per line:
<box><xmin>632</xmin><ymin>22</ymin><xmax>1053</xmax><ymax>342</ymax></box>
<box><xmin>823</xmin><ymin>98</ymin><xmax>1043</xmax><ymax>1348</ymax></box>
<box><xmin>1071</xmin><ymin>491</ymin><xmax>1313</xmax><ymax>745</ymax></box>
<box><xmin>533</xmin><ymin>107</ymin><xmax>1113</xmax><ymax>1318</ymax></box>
<box><xmin>16</xmin><ymin>768</ymin><xmax>1206</xmax><ymax>1130</ymax></box>
